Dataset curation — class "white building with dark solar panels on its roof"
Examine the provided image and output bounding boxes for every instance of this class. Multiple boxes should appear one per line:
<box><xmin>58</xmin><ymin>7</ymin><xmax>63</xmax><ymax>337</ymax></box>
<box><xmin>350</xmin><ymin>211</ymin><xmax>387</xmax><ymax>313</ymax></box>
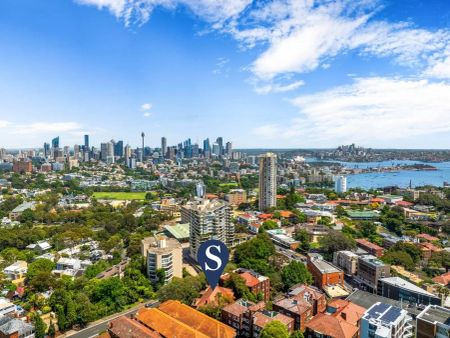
<box><xmin>360</xmin><ymin>302</ymin><xmax>413</xmax><ymax>338</ymax></box>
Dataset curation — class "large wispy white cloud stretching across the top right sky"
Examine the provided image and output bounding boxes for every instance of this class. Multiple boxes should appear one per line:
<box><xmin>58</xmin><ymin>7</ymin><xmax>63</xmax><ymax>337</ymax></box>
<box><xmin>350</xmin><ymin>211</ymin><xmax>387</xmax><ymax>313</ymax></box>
<box><xmin>75</xmin><ymin>0</ymin><xmax>450</xmax><ymax>87</ymax></box>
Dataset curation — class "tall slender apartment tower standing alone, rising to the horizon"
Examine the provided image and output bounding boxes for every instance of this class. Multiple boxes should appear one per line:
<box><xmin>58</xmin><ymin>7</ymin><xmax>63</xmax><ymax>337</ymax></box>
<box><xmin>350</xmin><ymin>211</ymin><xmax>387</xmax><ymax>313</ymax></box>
<box><xmin>259</xmin><ymin>153</ymin><xmax>277</xmax><ymax>211</ymax></box>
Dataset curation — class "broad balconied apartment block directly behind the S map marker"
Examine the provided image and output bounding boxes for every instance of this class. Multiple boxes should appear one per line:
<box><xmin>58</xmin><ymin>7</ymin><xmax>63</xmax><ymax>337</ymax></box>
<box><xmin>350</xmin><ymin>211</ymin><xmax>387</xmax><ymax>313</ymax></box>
<box><xmin>181</xmin><ymin>198</ymin><xmax>234</xmax><ymax>259</ymax></box>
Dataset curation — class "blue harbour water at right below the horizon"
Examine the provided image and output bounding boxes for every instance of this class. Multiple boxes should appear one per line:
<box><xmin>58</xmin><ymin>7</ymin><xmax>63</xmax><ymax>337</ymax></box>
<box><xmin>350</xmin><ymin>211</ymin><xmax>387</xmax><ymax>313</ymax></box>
<box><xmin>308</xmin><ymin>161</ymin><xmax>450</xmax><ymax>189</ymax></box>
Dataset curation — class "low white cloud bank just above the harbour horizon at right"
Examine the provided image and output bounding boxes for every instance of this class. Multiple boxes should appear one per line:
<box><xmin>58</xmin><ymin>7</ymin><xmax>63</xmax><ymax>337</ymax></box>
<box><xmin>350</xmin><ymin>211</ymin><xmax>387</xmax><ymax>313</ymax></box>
<box><xmin>253</xmin><ymin>77</ymin><xmax>450</xmax><ymax>146</ymax></box>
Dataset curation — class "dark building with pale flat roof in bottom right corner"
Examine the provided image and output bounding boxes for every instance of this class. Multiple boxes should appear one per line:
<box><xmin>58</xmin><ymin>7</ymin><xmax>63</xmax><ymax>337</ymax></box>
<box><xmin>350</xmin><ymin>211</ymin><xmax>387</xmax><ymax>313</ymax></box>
<box><xmin>416</xmin><ymin>305</ymin><xmax>450</xmax><ymax>338</ymax></box>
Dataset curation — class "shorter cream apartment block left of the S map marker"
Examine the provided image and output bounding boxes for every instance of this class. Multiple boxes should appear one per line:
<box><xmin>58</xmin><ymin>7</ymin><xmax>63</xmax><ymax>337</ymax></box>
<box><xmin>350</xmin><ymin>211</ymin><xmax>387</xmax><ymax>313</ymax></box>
<box><xmin>141</xmin><ymin>235</ymin><xmax>183</xmax><ymax>284</ymax></box>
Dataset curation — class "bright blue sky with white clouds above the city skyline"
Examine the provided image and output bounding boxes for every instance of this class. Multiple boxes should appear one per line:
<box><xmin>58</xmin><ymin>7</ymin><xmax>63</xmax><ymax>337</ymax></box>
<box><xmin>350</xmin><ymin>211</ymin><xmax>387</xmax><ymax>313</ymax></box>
<box><xmin>0</xmin><ymin>0</ymin><xmax>450</xmax><ymax>148</ymax></box>
